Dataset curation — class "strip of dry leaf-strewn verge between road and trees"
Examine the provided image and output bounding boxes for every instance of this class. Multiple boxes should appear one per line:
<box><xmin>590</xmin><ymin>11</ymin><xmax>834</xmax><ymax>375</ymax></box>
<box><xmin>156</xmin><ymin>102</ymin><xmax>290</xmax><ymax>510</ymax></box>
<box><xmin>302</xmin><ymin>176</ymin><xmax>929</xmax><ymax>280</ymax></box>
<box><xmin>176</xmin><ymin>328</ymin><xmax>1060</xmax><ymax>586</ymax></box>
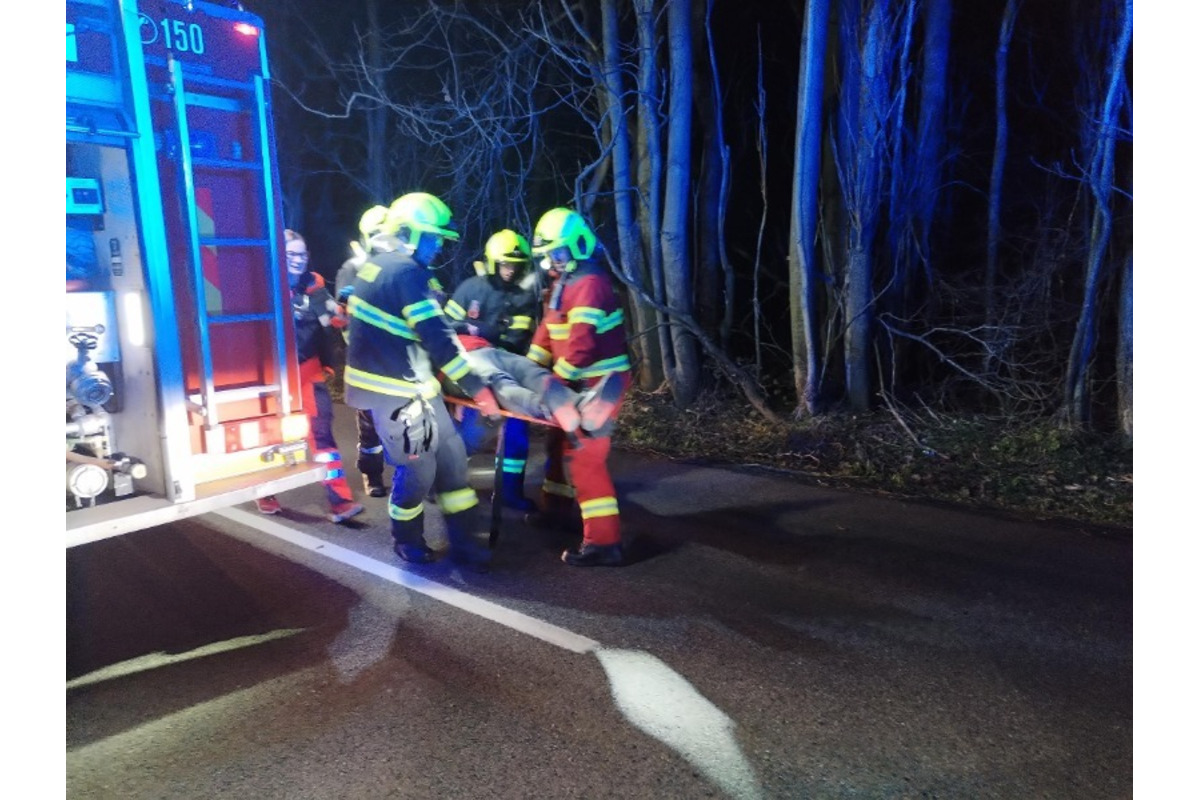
<box><xmin>616</xmin><ymin>392</ymin><xmax>1133</xmax><ymax>529</ymax></box>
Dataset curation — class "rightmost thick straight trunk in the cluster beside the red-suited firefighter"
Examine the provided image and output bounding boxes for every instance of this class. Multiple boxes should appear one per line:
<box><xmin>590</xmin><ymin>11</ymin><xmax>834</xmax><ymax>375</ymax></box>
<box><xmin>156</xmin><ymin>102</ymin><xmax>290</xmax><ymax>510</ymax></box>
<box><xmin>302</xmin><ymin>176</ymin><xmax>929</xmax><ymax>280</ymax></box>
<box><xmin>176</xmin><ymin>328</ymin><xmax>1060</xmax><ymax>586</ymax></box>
<box><xmin>661</xmin><ymin>0</ymin><xmax>700</xmax><ymax>408</ymax></box>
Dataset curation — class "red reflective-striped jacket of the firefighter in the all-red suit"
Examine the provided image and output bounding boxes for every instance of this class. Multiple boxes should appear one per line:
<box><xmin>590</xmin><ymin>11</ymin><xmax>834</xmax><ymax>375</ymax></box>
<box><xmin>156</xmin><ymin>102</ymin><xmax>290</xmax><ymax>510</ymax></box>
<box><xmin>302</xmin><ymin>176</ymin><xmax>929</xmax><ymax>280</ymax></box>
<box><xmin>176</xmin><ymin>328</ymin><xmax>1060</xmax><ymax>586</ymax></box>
<box><xmin>527</xmin><ymin>261</ymin><xmax>630</xmax><ymax>386</ymax></box>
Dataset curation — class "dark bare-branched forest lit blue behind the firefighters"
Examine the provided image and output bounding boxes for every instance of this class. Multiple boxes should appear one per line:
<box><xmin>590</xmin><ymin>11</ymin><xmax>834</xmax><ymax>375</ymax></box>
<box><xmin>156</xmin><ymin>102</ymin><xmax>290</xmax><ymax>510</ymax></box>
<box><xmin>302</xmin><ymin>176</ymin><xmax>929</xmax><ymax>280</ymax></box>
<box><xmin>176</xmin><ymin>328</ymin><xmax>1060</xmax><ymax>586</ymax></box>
<box><xmin>244</xmin><ymin>0</ymin><xmax>1133</xmax><ymax>470</ymax></box>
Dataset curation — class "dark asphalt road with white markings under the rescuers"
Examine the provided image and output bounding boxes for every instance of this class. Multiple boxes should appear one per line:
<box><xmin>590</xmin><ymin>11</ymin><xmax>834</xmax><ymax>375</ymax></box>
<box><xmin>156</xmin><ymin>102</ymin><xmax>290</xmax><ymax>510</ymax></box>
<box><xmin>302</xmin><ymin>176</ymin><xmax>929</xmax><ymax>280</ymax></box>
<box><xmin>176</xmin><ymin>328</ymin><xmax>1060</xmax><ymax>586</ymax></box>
<box><xmin>66</xmin><ymin>407</ymin><xmax>1133</xmax><ymax>800</ymax></box>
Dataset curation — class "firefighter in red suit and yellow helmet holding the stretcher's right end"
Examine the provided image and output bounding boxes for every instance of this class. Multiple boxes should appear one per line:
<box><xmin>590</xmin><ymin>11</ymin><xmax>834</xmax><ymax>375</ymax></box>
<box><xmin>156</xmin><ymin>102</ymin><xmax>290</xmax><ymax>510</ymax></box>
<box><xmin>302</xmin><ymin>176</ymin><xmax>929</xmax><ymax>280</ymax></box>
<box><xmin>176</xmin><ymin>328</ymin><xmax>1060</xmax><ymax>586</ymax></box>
<box><xmin>528</xmin><ymin>207</ymin><xmax>630</xmax><ymax>566</ymax></box>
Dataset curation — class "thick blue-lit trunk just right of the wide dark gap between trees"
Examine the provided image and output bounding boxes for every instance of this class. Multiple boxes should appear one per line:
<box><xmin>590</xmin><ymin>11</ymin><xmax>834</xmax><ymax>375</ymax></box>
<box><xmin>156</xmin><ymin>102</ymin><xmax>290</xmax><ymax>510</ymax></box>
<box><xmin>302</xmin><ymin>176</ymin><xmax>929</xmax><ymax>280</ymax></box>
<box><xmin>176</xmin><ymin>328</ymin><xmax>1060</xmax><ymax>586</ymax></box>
<box><xmin>787</xmin><ymin>0</ymin><xmax>829</xmax><ymax>416</ymax></box>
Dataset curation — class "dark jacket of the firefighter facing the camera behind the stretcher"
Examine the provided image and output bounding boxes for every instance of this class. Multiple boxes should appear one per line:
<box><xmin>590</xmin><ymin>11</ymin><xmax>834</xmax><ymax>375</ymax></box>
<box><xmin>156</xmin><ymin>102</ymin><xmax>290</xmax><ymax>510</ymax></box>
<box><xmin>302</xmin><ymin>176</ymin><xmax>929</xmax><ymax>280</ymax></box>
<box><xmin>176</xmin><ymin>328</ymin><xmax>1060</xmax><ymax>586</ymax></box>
<box><xmin>445</xmin><ymin>275</ymin><xmax>538</xmax><ymax>355</ymax></box>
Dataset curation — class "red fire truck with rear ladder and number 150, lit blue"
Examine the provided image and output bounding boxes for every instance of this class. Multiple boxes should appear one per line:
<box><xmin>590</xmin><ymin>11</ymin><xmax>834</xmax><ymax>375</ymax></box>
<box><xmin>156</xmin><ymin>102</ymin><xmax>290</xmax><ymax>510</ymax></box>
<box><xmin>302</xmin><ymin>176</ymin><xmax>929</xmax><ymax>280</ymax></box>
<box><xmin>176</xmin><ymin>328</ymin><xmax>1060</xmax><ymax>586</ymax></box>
<box><xmin>62</xmin><ymin>0</ymin><xmax>323</xmax><ymax>547</ymax></box>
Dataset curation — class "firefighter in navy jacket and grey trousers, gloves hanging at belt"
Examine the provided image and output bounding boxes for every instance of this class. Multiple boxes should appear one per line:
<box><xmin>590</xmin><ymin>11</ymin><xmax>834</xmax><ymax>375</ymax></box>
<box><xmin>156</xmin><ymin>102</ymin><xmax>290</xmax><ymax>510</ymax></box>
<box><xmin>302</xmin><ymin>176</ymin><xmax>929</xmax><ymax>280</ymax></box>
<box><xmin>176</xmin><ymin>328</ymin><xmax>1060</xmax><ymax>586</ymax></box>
<box><xmin>344</xmin><ymin>192</ymin><xmax>499</xmax><ymax>572</ymax></box>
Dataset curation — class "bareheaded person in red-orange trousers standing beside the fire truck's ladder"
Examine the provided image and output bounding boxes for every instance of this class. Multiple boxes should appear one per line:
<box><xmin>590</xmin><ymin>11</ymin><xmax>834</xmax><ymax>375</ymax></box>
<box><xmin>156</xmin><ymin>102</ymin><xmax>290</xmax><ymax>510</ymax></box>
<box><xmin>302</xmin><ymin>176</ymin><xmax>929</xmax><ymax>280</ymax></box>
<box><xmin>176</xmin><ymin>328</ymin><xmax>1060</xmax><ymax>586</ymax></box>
<box><xmin>256</xmin><ymin>229</ymin><xmax>362</xmax><ymax>523</ymax></box>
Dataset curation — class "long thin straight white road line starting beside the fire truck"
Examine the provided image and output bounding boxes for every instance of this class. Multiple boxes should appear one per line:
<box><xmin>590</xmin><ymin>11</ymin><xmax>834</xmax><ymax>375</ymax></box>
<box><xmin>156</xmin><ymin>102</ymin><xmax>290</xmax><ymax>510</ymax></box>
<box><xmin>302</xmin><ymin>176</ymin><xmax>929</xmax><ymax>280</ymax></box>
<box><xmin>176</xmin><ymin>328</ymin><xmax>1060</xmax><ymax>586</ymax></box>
<box><xmin>211</xmin><ymin>509</ymin><xmax>600</xmax><ymax>654</ymax></box>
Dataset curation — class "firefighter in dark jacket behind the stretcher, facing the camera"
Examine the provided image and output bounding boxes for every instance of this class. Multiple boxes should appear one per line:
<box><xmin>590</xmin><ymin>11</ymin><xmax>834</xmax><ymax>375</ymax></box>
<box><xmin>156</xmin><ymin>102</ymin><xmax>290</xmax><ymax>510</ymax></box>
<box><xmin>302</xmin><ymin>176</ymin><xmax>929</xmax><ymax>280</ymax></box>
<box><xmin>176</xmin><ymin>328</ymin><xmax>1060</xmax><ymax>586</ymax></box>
<box><xmin>445</xmin><ymin>229</ymin><xmax>539</xmax><ymax>511</ymax></box>
